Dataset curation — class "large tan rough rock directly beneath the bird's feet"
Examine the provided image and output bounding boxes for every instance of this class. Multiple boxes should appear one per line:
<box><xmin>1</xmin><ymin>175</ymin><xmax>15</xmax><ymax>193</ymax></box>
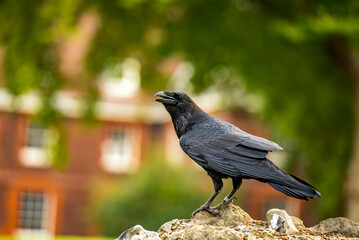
<box><xmin>157</xmin><ymin>204</ymin><xmax>325</xmax><ymax>240</ymax></box>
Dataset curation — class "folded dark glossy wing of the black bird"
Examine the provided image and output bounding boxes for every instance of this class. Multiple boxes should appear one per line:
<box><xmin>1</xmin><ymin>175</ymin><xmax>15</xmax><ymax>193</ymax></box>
<box><xmin>180</xmin><ymin>130</ymin><xmax>282</xmax><ymax>179</ymax></box>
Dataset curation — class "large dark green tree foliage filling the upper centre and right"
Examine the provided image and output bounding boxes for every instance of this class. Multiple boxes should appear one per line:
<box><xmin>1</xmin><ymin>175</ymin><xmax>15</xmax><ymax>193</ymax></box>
<box><xmin>84</xmin><ymin>0</ymin><xmax>359</xmax><ymax>217</ymax></box>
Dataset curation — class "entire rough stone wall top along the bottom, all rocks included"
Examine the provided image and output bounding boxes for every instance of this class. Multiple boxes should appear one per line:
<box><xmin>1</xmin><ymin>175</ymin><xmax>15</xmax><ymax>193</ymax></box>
<box><xmin>118</xmin><ymin>204</ymin><xmax>359</xmax><ymax>240</ymax></box>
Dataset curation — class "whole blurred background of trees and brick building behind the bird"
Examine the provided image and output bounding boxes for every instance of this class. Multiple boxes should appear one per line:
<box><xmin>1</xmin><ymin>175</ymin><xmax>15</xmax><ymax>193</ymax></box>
<box><xmin>0</xmin><ymin>0</ymin><xmax>359</xmax><ymax>240</ymax></box>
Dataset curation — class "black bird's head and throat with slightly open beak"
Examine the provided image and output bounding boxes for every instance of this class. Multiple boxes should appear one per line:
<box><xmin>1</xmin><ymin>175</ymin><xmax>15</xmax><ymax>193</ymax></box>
<box><xmin>155</xmin><ymin>91</ymin><xmax>205</xmax><ymax>136</ymax></box>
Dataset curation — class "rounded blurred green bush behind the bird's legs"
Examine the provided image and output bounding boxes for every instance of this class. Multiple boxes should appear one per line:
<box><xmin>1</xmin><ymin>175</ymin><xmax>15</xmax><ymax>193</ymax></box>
<box><xmin>92</xmin><ymin>159</ymin><xmax>210</xmax><ymax>237</ymax></box>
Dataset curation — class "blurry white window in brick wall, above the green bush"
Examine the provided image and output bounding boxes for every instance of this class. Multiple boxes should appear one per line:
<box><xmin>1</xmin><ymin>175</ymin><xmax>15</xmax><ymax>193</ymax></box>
<box><xmin>101</xmin><ymin>127</ymin><xmax>136</xmax><ymax>173</ymax></box>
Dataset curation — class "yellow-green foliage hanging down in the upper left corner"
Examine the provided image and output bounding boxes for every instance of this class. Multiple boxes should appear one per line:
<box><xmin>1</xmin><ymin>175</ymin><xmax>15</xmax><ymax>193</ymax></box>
<box><xmin>0</xmin><ymin>0</ymin><xmax>80</xmax><ymax>169</ymax></box>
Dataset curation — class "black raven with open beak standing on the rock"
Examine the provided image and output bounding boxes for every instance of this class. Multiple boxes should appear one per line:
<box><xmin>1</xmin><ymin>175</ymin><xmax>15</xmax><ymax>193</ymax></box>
<box><xmin>155</xmin><ymin>91</ymin><xmax>321</xmax><ymax>216</ymax></box>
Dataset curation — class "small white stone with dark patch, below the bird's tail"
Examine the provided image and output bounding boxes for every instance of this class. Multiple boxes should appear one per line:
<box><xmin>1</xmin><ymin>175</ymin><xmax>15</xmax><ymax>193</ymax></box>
<box><xmin>266</xmin><ymin>208</ymin><xmax>299</xmax><ymax>234</ymax></box>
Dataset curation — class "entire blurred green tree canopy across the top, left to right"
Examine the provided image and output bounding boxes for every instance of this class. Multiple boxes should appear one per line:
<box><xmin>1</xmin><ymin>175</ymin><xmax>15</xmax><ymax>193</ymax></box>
<box><xmin>0</xmin><ymin>0</ymin><xmax>359</xmax><ymax>217</ymax></box>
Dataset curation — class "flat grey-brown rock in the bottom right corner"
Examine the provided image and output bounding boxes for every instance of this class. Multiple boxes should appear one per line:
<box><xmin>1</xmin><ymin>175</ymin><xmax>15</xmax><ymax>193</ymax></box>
<box><xmin>310</xmin><ymin>217</ymin><xmax>359</xmax><ymax>238</ymax></box>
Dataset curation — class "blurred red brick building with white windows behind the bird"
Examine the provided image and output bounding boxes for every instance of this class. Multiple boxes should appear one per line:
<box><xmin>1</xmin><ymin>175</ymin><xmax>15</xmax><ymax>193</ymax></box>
<box><xmin>0</xmin><ymin>89</ymin><xmax>318</xmax><ymax>235</ymax></box>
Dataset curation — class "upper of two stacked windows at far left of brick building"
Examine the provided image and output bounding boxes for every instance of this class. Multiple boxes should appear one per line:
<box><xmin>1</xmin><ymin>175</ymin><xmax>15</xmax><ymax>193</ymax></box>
<box><xmin>20</xmin><ymin>122</ymin><xmax>50</xmax><ymax>167</ymax></box>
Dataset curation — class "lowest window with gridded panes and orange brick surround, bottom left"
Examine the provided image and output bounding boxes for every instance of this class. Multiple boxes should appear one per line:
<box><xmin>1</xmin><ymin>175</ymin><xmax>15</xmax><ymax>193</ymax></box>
<box><xmin>17</xmin><ymin>191</ymin><xmax>49</xmax><ymax>231</ymax></box>
